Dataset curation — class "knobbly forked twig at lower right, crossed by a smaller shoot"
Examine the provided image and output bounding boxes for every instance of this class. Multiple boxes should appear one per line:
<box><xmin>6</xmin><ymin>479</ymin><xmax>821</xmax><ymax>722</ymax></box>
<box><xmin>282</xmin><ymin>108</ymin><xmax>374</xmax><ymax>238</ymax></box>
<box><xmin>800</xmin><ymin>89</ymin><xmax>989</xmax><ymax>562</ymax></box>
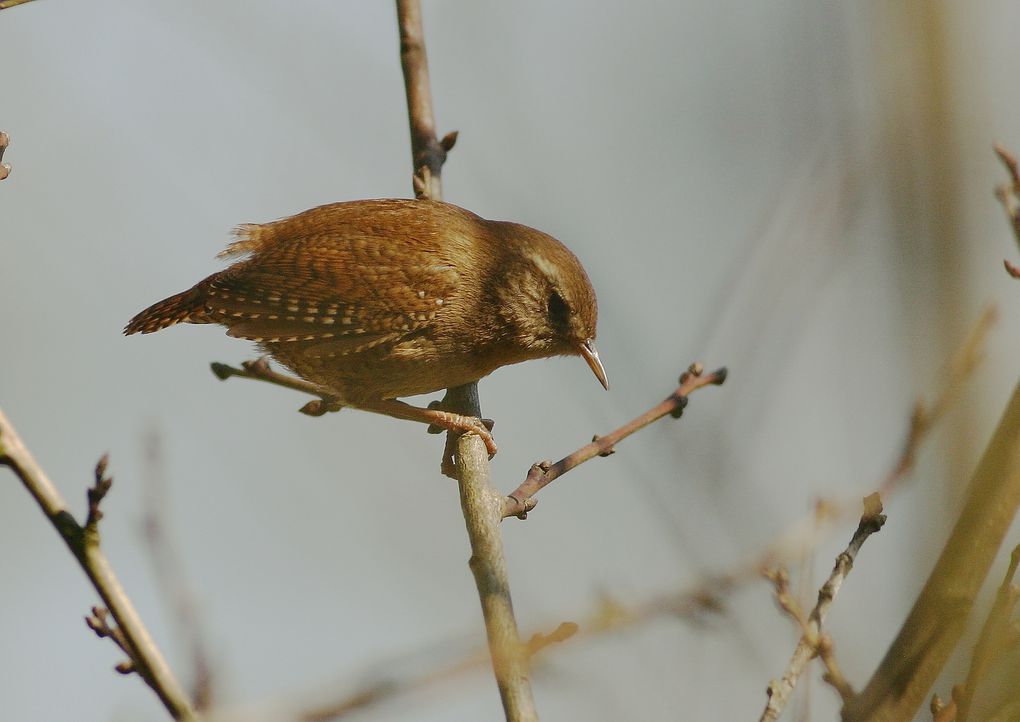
<box><xmin>761</xmin><ymin>494</ymin><xmax>885</xmax><ymax>722</ymax></box>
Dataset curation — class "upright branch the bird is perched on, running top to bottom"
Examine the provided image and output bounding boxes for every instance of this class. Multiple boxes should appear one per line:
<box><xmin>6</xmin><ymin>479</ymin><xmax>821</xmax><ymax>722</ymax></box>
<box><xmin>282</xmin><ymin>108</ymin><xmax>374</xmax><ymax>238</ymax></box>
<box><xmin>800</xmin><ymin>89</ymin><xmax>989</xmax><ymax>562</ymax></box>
<box><xmin>397</xmin><ymin>0</ymin><xmax>539</xmax><ymax>722</ymax></box>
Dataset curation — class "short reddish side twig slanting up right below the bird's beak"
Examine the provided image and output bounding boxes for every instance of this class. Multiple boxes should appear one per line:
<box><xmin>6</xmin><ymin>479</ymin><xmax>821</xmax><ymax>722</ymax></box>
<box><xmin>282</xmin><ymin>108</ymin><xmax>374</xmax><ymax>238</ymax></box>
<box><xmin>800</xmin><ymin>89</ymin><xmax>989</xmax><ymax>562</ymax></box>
<box><xmin>503</xmin><ymin>364</ymin><xmax>726</xmax><ymax>519</ymax></box>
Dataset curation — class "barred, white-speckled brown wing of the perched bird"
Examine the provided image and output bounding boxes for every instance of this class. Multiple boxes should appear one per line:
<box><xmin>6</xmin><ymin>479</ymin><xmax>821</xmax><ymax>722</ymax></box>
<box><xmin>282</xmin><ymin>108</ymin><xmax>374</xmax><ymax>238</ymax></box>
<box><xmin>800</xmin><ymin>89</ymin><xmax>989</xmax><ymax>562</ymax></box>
<box><xmin>204</xmin><ymin>236</ymin><xmax>459</xmax><ymax>356</ymax></box>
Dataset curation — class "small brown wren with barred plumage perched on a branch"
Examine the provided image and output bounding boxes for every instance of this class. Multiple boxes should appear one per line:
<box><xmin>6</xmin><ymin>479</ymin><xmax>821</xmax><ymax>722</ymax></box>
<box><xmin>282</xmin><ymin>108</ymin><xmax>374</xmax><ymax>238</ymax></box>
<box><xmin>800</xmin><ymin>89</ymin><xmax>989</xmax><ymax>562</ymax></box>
<box><xmin>124</xmin><ymin>199</ymin><xmax>609</xmax><ymax>455</ymax></box>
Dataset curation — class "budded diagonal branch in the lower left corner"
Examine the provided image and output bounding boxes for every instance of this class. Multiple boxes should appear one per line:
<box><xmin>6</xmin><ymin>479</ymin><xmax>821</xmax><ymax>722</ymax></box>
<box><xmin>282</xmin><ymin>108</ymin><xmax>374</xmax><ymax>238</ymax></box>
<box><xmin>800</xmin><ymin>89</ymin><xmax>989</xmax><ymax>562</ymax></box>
<box><xmin>0</xmin><ymin>412</ymin><xmax>196</xmax><ymax>721</ymax></box>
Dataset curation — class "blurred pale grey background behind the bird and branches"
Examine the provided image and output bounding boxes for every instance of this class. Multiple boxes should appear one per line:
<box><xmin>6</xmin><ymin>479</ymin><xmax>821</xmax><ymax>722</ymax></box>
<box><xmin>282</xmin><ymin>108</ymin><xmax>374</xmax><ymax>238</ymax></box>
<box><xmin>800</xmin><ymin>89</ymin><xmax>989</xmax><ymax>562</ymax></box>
<box><xmin>0</xmin><ymin>0</ymin><xmax>1020</xmax><ymax>722</ymax></box>
